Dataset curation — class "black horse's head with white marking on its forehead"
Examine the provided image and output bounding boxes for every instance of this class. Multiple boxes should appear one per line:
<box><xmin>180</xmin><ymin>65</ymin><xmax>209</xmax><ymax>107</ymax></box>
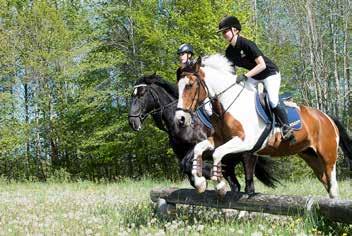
<box><xmin>128</xmin><ymin>74</ymin><xmax>159</xmax><ymax>131</ymax></box>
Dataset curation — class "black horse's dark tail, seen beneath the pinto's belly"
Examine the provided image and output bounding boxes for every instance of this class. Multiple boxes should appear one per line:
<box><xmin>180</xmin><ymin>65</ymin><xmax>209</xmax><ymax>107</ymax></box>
<box><xmin>254</xmin><ymin>157</ymin><xmax>280</xmax><ymax>188</ymax></box>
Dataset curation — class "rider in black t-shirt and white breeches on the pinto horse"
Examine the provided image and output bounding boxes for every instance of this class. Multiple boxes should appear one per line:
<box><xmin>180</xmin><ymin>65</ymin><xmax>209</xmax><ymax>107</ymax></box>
<box><xmin>218</xmin><ymin>16</ymin><xmax>294</xmax><ymax>140</ymax></box>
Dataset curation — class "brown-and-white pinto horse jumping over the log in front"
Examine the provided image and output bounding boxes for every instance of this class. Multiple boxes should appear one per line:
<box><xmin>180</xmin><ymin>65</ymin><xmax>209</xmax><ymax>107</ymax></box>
<box><xmin>175</xmin><ymin>54</ymin><xmax>352</xmax><ymax>198</ymax></box>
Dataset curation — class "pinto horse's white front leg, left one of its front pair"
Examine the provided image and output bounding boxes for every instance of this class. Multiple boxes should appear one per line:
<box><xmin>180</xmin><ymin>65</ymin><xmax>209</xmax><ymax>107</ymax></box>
<box><xmin>192</xmin><ymin>137</ymin><xmax>214</xmax><ymax>193</ymax></box>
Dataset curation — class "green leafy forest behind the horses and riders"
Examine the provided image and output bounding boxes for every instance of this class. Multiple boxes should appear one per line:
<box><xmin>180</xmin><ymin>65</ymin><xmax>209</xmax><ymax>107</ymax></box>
<box><xmin>0</xmin><ymin>0</ymin><xmax>352</xmax><ymax>181</ymax></box>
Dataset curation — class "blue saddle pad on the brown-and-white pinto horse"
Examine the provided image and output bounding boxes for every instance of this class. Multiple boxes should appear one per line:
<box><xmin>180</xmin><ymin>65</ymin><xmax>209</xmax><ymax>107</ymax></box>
<box><xmin>255</xmin><ymin>93</ymin><xmax>302</xmax><ymax>130</ymax></box>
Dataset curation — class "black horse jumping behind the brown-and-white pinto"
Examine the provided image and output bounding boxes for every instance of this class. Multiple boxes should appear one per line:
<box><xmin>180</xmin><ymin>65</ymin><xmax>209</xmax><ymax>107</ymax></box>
<box><xmin>128</xmin><ymin>74</ymin><xmax>278</xmax><ymax>193</ymax></box>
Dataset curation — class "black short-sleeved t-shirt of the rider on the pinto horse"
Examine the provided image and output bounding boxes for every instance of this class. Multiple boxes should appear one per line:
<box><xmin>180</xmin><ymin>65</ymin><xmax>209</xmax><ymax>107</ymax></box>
<box><xmin>226</xmin><ymin>36</ymin><xmax>279</xmax><ymax>80</ymax></box>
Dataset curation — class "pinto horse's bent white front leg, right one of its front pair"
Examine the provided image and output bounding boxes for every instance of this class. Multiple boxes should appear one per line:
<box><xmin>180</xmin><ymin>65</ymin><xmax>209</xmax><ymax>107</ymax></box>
<box><xmin>212</xmin><ymin>137</ymin><xmax>253</xmax><ymax>196</ymax></box>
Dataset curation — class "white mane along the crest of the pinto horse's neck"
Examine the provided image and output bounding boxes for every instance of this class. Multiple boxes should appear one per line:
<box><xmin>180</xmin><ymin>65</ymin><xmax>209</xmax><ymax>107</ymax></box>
<box><xmin>202</xmin><ymin>54</ymin><xmax>235</xmax><ymax>76</ymax></box>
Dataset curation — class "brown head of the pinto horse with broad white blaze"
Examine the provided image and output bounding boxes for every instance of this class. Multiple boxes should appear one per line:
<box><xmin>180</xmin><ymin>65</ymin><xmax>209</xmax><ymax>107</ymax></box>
<box><xmin>175</xmin><ymin>57</ymin><xmax>208</xmax><ymax>126</ymax></box>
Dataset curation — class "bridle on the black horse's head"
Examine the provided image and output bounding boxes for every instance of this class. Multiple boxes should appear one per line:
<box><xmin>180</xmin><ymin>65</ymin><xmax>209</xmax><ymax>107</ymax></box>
<box><xmin>128</xmin><ymin>84</ymin><xmax>177</xmax><ymax>126</ymax></box>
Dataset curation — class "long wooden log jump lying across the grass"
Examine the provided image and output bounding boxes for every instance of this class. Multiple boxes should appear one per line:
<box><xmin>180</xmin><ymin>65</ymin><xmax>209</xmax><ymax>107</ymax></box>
<box><xmin>150</xmin><ymin>188</ymin><xmax>352</xmax><ymax>224</ymax></box>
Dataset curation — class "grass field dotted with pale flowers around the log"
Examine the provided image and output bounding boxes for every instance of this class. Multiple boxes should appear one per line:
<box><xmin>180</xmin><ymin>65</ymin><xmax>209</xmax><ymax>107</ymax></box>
<box><xmin>0</xmin><ymin>179</ymin><xmax>352</xmax><ymax>236</ymax></box>
